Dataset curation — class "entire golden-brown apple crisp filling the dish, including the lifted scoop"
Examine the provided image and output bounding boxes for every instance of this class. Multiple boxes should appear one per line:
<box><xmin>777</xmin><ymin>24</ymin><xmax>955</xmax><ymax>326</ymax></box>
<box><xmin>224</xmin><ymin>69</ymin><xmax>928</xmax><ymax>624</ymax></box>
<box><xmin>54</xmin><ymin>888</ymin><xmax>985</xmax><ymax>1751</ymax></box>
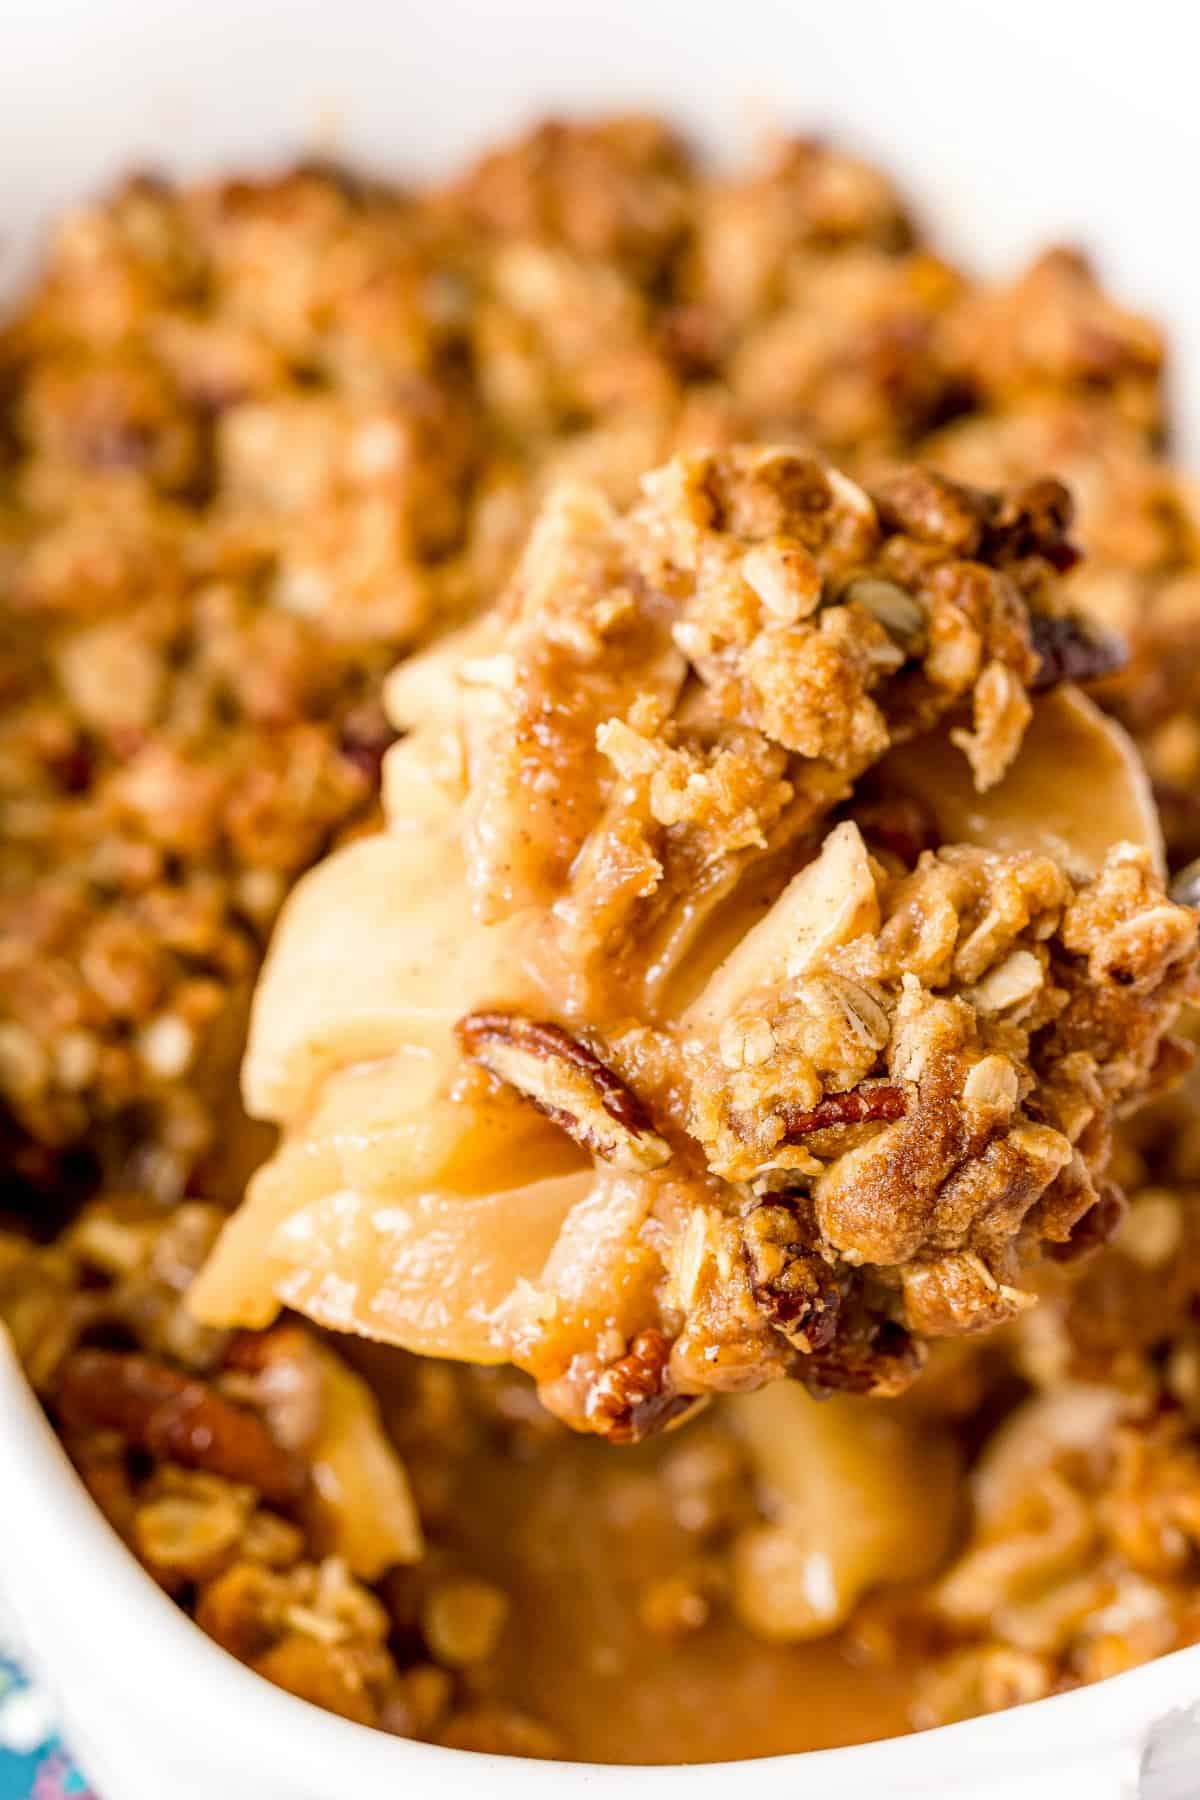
<box><xmin>0</xmin><ymin>117</ymin><xmax>1200</xmax><ymax>1762</ymax></box>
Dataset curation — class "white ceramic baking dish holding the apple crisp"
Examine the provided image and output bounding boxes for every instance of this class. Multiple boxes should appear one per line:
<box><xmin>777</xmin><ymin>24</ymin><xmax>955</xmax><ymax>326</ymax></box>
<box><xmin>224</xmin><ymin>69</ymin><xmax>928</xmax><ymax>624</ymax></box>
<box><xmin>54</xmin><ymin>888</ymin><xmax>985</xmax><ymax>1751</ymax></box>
<box><xmin>0</xmin><ymin>0</ymin><xmax>1200</xmax><ymax>1800</ymax></box>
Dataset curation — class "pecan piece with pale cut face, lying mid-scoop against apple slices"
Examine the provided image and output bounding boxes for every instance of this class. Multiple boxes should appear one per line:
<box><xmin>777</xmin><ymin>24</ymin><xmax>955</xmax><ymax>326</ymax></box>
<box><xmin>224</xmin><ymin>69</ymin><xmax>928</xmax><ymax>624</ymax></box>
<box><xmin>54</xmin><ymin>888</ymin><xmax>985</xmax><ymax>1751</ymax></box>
<box><xmin>455</xmin><ymin>1012</ymin><xmax>671</xmax><ymax>1174</ymax></box>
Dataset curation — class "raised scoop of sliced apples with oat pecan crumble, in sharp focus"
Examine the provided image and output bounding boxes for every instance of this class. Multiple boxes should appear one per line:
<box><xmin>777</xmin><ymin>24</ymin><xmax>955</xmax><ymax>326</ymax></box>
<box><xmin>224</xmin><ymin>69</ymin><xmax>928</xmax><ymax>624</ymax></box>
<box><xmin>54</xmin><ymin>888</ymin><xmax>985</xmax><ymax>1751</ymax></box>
<box><xmin>191</xmin><ymin>450</ymin><xmax>1196</xmax><ymax>1442</ymax></box>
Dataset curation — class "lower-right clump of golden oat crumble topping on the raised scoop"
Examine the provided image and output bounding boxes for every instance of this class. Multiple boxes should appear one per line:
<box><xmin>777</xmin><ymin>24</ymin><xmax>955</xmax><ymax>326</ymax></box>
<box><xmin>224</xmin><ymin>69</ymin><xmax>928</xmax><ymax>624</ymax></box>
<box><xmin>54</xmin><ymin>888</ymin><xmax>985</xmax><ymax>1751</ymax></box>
<box><xmin>644</xmin><ymin>826</ymin><xmax>1196</xmax><ymax>1391</ymax></box>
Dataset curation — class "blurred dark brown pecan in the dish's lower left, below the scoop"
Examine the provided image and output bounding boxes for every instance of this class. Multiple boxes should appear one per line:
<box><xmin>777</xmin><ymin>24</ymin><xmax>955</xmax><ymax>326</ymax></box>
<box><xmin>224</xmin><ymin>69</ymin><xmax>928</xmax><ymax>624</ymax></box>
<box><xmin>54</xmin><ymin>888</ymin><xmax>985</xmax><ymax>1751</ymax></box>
<box><xmin>56</xmin><ymin>1350</ymin><xmax>306</xmax><ymax>1505</ymax></box>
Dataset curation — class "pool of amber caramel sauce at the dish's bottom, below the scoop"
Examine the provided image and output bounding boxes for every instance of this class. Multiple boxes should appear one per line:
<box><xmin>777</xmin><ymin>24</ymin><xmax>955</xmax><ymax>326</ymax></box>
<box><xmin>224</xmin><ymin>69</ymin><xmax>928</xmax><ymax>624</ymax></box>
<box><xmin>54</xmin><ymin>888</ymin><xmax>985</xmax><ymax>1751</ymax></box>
<box><xmin>374</xmin><ymin>1368</ymin><xmax>909</xmax><ymax>1764</ymax></box>
